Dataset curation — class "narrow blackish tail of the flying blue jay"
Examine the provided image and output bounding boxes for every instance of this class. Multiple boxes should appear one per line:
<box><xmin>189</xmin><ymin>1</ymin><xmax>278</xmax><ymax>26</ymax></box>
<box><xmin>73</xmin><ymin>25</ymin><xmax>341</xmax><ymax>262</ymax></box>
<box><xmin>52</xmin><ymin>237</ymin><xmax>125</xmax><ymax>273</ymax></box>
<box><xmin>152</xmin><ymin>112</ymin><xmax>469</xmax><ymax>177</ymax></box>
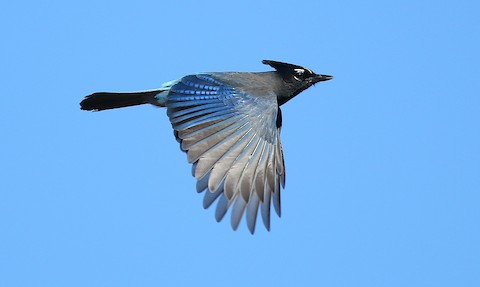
<box><xmin>80</xmin><ymin>90</ymin><xmax>161</xmax><ymax>111</ymax></box>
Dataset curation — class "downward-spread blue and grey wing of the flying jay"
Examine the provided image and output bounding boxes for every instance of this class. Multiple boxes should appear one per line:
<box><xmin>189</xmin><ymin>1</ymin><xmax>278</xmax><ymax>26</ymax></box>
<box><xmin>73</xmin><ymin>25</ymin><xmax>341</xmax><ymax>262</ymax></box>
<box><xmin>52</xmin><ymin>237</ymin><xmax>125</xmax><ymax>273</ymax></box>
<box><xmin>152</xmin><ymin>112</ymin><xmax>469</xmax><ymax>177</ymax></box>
<box><xmin>166</xmin><ymin>74</ymin><xmax>285</xmax><ymax>234</ymax></box>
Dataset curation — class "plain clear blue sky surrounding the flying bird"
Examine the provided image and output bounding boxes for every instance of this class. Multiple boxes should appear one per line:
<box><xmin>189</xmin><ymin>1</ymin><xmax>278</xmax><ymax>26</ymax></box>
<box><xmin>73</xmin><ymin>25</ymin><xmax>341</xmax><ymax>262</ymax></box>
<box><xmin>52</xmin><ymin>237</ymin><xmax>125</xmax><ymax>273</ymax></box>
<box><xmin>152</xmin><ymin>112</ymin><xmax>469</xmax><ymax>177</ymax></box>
<box><xmin>0</xmin><ymin>0</ymin><xmax>480</xmax><ymax>287</ymax></box>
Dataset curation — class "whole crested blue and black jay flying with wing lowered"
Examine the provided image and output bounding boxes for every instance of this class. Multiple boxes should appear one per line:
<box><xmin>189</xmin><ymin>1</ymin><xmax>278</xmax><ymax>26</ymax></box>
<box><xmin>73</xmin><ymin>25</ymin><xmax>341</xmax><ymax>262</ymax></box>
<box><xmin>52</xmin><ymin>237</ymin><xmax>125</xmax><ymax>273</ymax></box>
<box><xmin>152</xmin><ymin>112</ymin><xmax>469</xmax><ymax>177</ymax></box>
<box><xmin>80</xmin><ymin>60</ymin><xmax>333</xmax><ymax>234</ymax></box>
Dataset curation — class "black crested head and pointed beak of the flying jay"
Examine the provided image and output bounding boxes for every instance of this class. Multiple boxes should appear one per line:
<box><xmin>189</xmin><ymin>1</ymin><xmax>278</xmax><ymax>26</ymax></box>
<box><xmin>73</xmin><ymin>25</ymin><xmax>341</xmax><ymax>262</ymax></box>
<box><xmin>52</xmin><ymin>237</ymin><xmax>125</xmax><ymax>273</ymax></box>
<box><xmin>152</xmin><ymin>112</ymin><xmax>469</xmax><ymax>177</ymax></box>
<box><xmin>262</xmin><ymin>60</ymin><xmax>333</xmax><ymax>105</ymax></box>
